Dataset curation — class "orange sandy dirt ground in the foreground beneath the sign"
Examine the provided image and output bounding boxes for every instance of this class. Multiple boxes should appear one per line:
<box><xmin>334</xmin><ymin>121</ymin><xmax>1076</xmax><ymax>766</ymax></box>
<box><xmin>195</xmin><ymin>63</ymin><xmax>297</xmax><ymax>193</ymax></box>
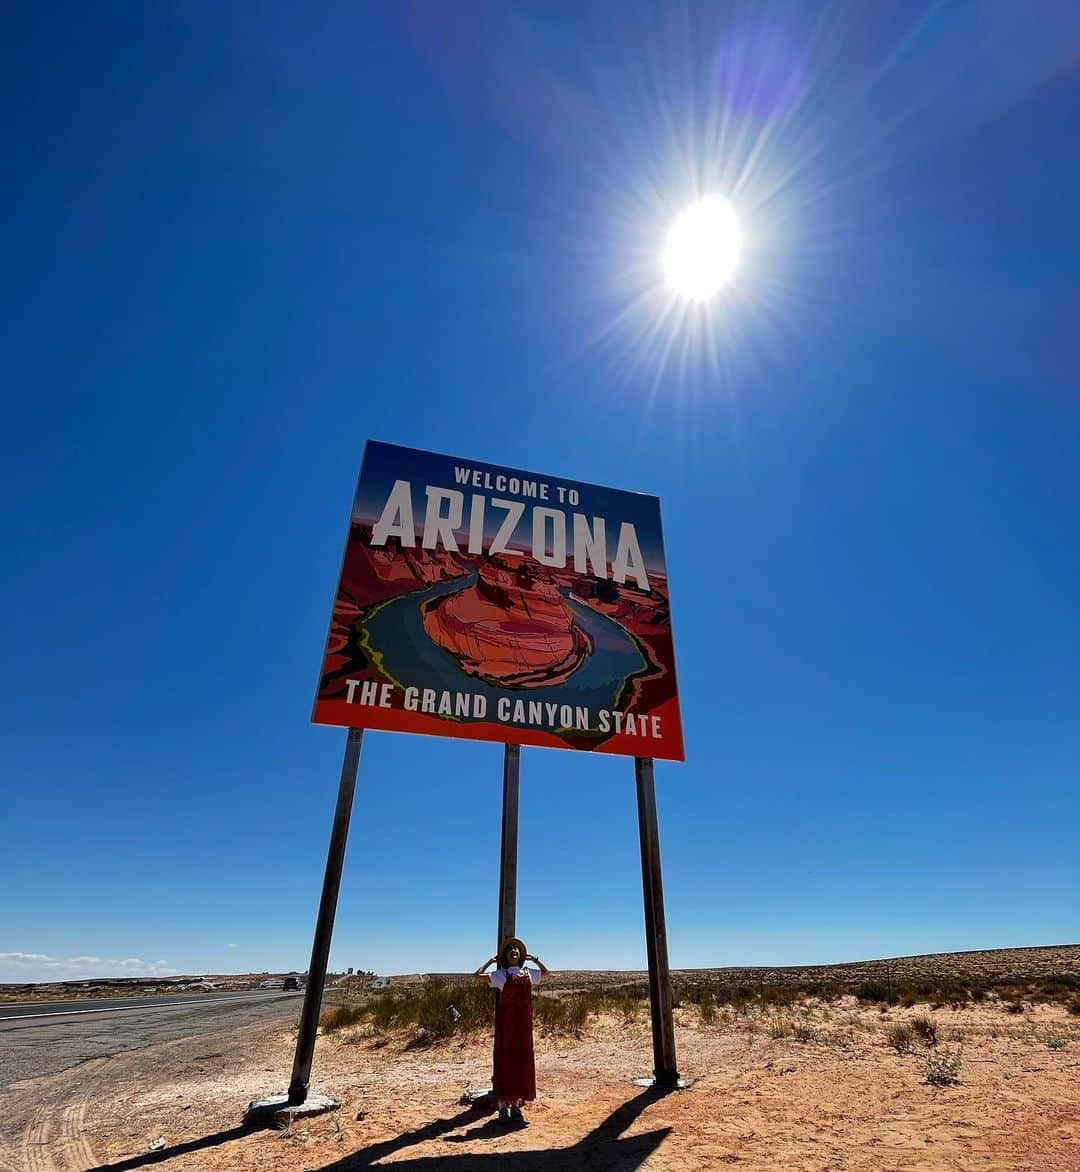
<box><xmin>0</xmin><ymin>997</ymin><xmax>1080</xmax><ymax>1172</ymax></box>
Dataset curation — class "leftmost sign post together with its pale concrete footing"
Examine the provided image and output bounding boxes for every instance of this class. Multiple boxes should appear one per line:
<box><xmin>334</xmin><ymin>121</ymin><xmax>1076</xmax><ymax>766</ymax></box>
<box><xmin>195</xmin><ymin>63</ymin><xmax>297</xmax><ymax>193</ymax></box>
<box><xmin>244</xmin><ymin>728</ymin><xmax>363</xmax><ymax>1122</ymax></box>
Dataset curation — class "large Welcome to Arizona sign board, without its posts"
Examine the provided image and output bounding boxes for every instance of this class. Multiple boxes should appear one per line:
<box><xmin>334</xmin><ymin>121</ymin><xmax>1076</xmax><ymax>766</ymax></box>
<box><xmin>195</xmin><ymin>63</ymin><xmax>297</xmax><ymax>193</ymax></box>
<box><xmin>313</xmin><ymin>441</ymin><xmax>683</xmax><ymax>761</ymax></box>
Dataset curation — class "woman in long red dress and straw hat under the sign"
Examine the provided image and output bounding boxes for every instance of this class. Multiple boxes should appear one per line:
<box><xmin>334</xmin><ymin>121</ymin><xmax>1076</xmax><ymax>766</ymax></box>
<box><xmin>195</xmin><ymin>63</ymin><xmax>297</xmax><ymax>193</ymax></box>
<box><xmin>473</xmin><ymin>936</ymin><xmax>548</xmax><ymax>1125</ymax></box>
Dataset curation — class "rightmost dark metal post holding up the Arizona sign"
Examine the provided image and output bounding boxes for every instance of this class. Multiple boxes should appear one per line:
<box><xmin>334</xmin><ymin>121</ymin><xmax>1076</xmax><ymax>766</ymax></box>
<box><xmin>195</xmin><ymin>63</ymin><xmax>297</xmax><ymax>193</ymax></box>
<box><xmin>634</xmin><ymin>757</ymin><xmax>679</xmax><ymax>1086</ymax></box>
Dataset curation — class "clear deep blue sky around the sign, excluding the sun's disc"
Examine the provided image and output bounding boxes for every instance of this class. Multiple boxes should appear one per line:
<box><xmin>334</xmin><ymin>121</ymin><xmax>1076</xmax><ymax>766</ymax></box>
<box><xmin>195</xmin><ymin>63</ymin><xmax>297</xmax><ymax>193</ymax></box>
<box><xmin>0</xmin><ymin>0</ymin><xmax>1080</xmax><ymax>980</ymax></box>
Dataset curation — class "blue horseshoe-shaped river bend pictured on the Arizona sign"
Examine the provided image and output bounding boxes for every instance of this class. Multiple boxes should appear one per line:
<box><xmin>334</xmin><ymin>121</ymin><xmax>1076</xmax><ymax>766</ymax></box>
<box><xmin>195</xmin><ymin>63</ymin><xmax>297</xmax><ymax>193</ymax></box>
<box><xmin>356</xmin><ymin>573</ymin><xmax>652</xmax><ymax>731</ymax></box>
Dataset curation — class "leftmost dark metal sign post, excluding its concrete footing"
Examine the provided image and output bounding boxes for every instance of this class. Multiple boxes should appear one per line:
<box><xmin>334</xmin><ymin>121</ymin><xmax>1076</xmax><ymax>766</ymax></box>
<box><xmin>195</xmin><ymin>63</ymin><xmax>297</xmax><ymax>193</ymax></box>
<box><xmin>288</xmin><ymin>729</ymin><xmax>363</xmax><ymax>1106</ymax></box>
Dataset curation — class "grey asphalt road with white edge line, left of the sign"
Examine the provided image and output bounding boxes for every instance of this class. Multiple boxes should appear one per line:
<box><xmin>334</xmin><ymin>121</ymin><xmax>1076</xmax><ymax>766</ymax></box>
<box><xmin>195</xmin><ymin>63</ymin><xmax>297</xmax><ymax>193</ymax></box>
<box><xmin>0</xmin><ymin>990</ymin><xmax>303</xmax><ymax>1088</ymax></box>
